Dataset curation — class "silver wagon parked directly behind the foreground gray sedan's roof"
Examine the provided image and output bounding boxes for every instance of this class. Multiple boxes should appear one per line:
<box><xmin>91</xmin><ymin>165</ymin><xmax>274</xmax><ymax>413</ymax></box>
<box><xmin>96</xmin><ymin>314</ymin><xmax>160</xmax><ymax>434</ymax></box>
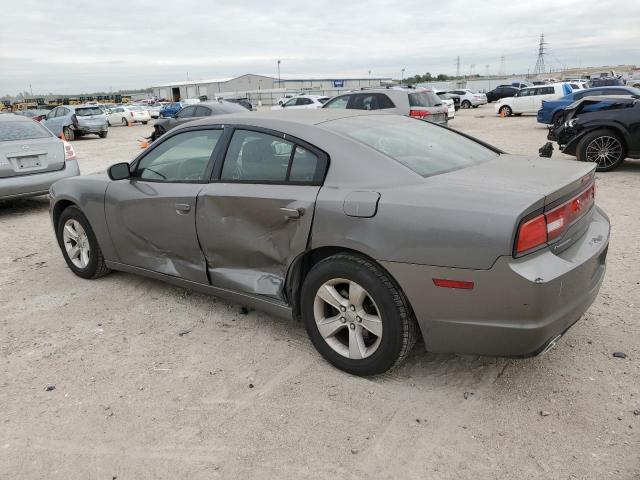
<box><xmin>322</xmin><ymin>87</ymin><xmax>449</xmax><ymax>125</ymax></box>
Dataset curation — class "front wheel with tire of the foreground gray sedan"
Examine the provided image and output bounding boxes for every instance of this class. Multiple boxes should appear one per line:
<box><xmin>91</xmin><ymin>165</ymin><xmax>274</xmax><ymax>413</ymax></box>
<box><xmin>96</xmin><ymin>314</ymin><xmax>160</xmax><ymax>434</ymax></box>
<box><xmin>57</xmin><ymin>206</ymin><xmax>111</xmax><ymax>279</ymax></box>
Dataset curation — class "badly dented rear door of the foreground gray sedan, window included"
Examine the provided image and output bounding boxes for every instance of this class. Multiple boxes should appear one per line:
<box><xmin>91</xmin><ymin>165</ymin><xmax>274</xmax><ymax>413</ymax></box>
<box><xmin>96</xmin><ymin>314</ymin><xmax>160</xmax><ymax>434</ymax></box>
<box><xmin>196</xmin><ymin>128</ymin><xmax>327</xmax><ymax>299</ymax></box>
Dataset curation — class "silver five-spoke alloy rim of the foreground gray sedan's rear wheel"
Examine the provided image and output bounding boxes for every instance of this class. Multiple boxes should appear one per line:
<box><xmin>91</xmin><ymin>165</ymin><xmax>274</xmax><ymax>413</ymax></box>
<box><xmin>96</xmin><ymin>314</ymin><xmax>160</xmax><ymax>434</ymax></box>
<box><xmin>313</xmin><ymin>278</ymin><xmax>383</xmax><ymax>360</ymax></box>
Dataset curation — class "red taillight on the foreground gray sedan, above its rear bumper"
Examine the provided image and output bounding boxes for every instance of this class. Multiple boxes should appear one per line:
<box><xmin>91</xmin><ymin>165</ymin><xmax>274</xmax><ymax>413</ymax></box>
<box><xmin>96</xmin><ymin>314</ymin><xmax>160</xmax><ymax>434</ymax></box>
<box><xmin>516</xmin><ymin>183</ymin><xmax>596</xmax><ymax>253</ymax></box>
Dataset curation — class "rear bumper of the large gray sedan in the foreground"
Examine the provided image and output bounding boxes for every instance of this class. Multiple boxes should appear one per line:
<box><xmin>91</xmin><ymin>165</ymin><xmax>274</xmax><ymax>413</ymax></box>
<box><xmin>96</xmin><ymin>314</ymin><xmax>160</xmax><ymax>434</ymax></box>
<box><xmin>383</xmin><ymin>208</ymin><xmax>610</xmax><ymax>356</ymax></box>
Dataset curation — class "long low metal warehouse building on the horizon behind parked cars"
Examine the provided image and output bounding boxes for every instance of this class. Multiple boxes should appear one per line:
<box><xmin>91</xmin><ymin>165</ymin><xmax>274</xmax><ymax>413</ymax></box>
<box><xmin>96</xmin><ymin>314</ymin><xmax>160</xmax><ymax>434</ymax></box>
<box><xmin>153</xmin><ymin>73</ymin><xmax>392</xmax><ymax>104</ymax></box>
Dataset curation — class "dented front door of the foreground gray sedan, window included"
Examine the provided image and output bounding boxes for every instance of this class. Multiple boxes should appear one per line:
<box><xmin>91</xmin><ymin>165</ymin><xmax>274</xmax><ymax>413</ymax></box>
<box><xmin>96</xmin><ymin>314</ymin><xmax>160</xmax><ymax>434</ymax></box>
<box><xmin>105</xmin><ymin>129</ymin><xmax>222</xmax><ymax>284</ymax></box>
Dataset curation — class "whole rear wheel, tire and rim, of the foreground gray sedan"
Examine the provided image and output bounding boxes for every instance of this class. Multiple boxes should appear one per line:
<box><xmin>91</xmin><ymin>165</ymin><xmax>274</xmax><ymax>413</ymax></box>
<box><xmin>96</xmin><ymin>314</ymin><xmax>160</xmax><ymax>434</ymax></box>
<box><xmin>301</xmin><ymin>254</ymin><xmax>418</xmax><ymax>375</ymax></box>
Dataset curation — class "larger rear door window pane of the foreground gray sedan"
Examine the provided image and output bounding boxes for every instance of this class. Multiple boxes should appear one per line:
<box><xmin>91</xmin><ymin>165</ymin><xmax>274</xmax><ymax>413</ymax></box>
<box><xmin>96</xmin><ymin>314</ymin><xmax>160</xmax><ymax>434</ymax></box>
<box><xmin>220</xmin><ymin>130</ymin><xmax>293</xmax><ymax>182</ymax></box>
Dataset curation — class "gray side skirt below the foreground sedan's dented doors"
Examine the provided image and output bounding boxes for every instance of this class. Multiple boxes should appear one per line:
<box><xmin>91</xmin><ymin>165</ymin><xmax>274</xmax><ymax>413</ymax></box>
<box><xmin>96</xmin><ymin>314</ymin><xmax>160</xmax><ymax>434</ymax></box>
<box><xmin>104</xmin><ymin>260</ymin><xmax>293</xmax><ymax>319</ymax></box>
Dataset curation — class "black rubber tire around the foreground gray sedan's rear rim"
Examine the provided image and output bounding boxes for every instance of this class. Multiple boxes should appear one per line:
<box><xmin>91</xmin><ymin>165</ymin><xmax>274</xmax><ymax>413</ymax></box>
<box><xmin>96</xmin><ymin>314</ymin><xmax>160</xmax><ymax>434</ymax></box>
<box><xmin>301</xmin><ymin>253</ymin><xmax>418</xmax><ymax>376</ymax></box>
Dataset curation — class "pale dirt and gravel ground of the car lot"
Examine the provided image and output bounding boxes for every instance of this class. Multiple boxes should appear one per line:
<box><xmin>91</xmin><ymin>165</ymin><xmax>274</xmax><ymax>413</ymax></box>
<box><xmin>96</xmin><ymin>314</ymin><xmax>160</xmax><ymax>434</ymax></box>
<box><xmin>0</xmin><ymin>105</ymin><xmax>640</xmax><ymax>480</ymax></box>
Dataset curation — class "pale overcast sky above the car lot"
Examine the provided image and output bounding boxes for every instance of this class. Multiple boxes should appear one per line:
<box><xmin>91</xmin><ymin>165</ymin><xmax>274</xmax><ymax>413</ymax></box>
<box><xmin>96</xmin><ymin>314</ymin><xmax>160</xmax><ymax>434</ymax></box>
<box><xmin>0</xmin><ymin>0</ymin><xmax>640</xmax><ymax>95</ymax></box>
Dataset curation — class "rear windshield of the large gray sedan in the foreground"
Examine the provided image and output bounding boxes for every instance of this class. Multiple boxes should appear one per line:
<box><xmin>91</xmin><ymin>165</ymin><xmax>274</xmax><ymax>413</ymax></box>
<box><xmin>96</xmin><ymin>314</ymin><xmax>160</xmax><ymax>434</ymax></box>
<box><xmin>324</xmin><ymin>115</ymin><xmax>498</xmax><ymax>177</ymax></box>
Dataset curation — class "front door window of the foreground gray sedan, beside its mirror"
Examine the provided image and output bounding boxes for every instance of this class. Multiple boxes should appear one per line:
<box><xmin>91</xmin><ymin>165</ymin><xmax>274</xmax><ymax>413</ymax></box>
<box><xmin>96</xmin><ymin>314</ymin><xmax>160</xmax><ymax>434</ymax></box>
<box><xmin>133</xmin><ymin>130</ymin><xmax>222</xmax><ymax>182</ymax></box>
